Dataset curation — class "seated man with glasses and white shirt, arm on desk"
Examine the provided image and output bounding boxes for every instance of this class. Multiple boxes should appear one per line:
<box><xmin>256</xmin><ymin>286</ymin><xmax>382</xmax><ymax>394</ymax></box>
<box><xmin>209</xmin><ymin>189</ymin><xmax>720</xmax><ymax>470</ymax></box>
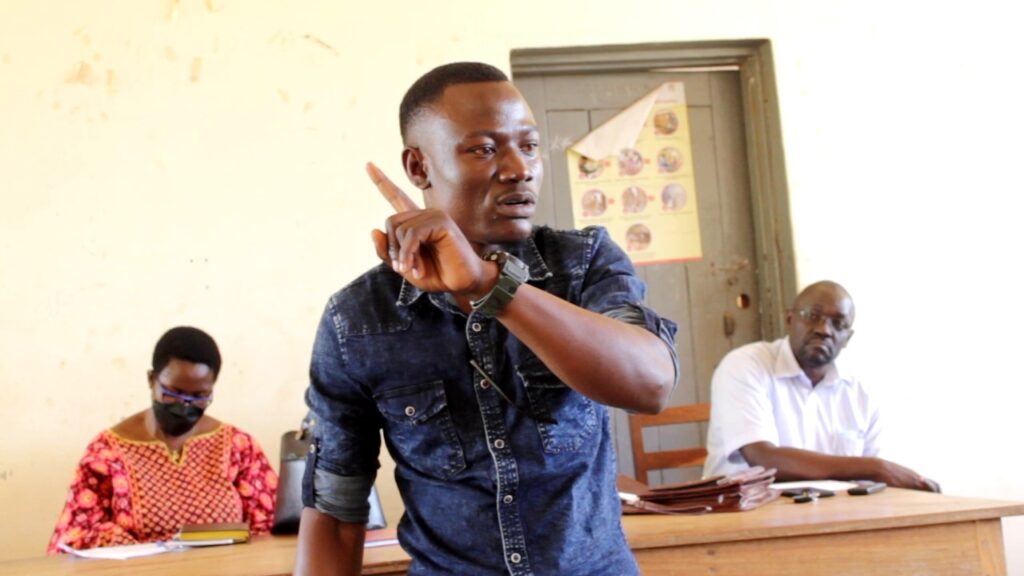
<box><xmin>703</xmin><ymin>281</ymin><xmax>939</xmax><ymax>492</ymax></box>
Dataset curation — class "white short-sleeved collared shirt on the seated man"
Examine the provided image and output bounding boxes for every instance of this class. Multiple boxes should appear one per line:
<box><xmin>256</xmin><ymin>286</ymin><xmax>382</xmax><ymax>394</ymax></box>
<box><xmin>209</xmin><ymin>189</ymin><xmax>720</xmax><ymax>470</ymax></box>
<box><xmin>703</xmin><ymin>338</ymin><xmax>882</xmax><ymax>476</ymax></box>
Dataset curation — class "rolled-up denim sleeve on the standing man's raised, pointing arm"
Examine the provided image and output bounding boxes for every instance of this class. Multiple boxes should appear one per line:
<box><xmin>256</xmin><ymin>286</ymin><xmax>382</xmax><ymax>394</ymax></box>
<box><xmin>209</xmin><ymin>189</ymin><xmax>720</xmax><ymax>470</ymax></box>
<box><xmin>580</xmin><ymin>227</ymin><xmax>679</xmax><ymax>383</ymax></box>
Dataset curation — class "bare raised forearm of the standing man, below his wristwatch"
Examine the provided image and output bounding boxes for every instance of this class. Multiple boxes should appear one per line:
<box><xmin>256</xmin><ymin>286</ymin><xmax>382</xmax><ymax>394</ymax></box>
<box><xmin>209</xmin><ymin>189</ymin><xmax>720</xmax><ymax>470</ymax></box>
<box><xmin>498</xmin><ymin>285</ymin><xmax>675</xmax><ymax>412</ymax></box>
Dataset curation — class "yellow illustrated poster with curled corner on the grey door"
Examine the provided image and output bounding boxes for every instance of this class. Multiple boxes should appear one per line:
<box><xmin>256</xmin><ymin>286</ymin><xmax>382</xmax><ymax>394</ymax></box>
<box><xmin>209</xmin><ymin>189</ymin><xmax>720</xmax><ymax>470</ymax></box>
<box><xmin>566</xmin><ymin>82</ymin><xmax>702</xmax><ymax>265</ymax></box>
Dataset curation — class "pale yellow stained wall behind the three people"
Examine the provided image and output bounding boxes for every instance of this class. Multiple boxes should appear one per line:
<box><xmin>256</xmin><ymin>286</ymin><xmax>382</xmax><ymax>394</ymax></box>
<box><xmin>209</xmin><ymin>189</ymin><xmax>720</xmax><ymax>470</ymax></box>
<box><xmin>0</xmin><ymin>0</ymin><xmax>1024</xmax><ymax>574</ymax></box>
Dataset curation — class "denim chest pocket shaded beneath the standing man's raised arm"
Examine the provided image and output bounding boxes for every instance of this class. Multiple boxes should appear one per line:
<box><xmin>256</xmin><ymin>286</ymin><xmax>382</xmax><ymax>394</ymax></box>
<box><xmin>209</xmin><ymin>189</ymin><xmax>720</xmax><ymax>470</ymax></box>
<box><xmin>517</xmin><ymin>357</ymin><xmax>598</xmax><ymax>454</ymax></box>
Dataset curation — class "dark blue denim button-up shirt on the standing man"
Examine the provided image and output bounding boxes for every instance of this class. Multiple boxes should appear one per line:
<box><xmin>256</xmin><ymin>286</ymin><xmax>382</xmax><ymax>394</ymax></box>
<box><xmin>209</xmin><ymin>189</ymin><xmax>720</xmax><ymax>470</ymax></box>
<box><xmin>304</xmin><ymin>227</ymin><xmax>678</xmax><ymax>576</ymax></box>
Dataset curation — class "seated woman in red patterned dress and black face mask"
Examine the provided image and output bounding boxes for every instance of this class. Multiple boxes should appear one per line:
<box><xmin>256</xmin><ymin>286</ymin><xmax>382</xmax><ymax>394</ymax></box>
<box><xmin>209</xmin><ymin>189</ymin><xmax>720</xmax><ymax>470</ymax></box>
<box><xmin>47</xmin><ymin>327</ymin><xmax>278</xmax><ymax>553</ymax></box>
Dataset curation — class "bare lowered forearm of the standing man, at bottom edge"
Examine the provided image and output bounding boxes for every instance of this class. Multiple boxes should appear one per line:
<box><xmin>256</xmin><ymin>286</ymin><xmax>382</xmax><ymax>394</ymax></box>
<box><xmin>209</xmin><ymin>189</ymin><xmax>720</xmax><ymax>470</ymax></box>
<box><xmin>294</xmin><ymin>508</ymin><xmax>367</xmax><ymax>576</ymax></box>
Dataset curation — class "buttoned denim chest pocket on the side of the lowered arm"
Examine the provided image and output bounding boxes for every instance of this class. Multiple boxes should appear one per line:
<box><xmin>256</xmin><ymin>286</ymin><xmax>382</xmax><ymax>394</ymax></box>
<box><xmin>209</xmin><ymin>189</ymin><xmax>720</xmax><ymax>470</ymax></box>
<box><xmin>374</xmin><ymin>380</ymin><xmax>466</xmax><ymax>480</ymax></box>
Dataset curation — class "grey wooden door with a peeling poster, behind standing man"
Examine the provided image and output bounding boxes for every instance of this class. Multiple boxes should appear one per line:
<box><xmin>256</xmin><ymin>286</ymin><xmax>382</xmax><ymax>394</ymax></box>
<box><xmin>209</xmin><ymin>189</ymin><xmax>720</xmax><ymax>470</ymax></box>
<box><xmin>515</xmin><ymin>70</ymin><xmax>761</xmax><ymax>484</ymax></box>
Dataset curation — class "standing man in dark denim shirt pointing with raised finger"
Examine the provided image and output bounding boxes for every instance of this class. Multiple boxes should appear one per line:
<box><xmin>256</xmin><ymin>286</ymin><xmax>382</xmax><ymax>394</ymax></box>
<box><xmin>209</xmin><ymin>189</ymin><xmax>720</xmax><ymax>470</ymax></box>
<box><xmin>296</xmin><ymin>63</ymin><xmax>678</xmax><ymax>576</ymax></box>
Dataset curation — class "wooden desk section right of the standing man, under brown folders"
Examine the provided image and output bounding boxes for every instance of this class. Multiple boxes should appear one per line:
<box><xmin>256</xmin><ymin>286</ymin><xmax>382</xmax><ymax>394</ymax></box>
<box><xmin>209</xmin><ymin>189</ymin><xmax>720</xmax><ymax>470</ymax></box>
<box><xmin>626</xmin><ymin>488</ymin><xmax>1024</xmax><ymax>576</ymax></box>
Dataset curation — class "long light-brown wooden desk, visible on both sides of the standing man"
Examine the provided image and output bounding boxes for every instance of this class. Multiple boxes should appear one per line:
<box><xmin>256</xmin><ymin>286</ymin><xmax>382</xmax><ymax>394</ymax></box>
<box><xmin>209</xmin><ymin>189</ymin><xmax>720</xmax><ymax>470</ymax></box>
<box><xmin>0</xmin><ymin>489</ymin><xmax>1024</xmax><ymax>576</ymax></box>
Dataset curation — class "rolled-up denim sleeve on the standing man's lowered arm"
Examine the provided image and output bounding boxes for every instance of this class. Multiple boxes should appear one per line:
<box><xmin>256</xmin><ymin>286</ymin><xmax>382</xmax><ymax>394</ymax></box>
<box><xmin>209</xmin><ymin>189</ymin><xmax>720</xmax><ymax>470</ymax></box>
<box><xmin>302</xmin><ymin>298</ymin><xmax>382</xmax><ymax>522</ymax></box>
